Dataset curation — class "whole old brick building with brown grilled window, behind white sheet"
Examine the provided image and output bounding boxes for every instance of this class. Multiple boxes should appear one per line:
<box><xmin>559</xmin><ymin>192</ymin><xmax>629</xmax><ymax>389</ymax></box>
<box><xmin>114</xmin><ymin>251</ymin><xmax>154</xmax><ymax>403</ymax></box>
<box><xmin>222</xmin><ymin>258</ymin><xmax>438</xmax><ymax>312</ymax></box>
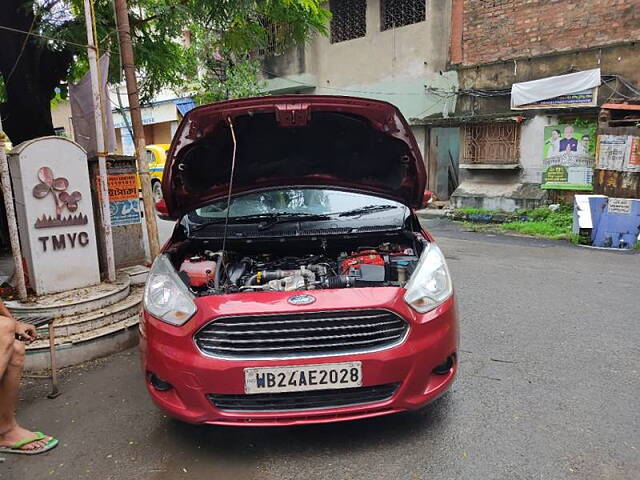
<box><xmin>414</xmin><ymin>0</ymin><xmax>640</xmax><ymax>210</ymax></box>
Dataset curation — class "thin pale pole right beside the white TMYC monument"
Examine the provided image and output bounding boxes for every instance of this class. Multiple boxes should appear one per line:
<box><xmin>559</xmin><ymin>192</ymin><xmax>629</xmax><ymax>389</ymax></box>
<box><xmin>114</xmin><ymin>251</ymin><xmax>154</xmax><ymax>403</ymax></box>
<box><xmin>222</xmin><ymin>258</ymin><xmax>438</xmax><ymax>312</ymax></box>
<box><xmin>84</xmin><ymin>0</ymin><xmax>116</xmax><ymax>282</ymax></box>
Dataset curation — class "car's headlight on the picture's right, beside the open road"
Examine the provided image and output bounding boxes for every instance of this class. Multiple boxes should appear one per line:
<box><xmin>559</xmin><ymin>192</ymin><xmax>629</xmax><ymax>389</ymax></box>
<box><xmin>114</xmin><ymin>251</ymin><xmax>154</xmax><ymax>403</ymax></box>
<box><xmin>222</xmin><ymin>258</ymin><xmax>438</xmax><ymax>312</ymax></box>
<box><xmin>404</xmin><ymin>243</ymin><xmax>453</xmax><ymax>313</ymax></box>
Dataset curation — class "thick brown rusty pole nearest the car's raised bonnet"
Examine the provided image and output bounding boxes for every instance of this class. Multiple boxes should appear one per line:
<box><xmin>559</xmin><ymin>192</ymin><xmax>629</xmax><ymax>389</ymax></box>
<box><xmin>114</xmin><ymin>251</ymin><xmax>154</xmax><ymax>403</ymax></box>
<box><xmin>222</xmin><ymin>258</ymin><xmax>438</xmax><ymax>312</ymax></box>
<box><xmin>113</xmin><ymin>0</ymin><xmax>160</xmax><ymax>261</ymax></box>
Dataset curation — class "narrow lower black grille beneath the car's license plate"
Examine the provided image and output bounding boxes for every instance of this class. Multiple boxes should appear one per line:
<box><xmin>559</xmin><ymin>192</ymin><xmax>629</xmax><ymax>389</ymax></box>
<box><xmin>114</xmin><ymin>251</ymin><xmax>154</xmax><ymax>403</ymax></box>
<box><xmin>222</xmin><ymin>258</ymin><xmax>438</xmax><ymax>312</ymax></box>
<box><xmin>208</xmin><ymin>383</ymin><xmax>400</xmax><ymax>412</ymax></box>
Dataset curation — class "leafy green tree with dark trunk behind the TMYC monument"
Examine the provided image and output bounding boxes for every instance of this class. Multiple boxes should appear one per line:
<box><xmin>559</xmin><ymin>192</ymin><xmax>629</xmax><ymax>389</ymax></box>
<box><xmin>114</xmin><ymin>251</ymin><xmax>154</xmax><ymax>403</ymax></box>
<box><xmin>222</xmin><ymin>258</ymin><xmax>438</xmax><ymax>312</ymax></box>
<box><xmin>0</xmin><ymin>0</ymin><xmax>330</xmax><ymax>144</ymax></box>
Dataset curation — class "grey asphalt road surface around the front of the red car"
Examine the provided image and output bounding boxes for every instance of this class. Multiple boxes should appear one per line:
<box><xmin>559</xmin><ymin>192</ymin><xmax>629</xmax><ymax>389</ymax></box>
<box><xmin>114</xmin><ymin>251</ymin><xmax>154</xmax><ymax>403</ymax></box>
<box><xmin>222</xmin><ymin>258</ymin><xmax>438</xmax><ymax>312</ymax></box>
<box><xmin>5</xmin><ymin>222</ymin><xmax>640</xmax><ymax>480</ymax></box>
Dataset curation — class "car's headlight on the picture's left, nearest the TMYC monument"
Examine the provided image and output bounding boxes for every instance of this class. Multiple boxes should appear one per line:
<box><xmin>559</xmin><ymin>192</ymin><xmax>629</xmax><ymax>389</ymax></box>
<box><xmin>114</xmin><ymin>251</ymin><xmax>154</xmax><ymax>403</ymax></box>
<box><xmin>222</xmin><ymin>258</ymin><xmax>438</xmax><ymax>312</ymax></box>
<box><xmin>143</xmin><ymin>255</ymin><xmax>197</xmax><ymax>326</ymax></box>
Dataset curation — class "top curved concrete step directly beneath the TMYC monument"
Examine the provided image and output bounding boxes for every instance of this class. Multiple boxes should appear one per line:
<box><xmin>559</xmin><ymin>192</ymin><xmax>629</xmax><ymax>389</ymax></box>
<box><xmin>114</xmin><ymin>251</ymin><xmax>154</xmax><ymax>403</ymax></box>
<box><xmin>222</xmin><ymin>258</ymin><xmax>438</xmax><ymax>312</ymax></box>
<box><xmin>5</xmin><ymin>272</ymin><xmax>131</xmax><ymax>318</ymax></box>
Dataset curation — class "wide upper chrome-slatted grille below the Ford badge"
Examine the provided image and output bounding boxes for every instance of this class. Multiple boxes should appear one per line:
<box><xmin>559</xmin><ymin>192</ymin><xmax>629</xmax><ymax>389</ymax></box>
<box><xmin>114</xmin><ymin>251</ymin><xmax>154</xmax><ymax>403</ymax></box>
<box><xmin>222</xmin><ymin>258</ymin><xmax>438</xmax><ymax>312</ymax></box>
<box><xmin>195</xmin><ymin>310</ymin><xmax>408</xmax><ymax>359</ymax></box>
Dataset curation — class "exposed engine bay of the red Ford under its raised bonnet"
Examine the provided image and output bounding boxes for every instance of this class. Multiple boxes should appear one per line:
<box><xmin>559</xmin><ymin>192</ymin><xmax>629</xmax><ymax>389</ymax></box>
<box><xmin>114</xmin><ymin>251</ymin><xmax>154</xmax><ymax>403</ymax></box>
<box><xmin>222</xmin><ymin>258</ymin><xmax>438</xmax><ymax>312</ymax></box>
<box><xmin>173</xmin><ymin>236</ymin><xmax>426</xmax><ymax>296</ymax></box>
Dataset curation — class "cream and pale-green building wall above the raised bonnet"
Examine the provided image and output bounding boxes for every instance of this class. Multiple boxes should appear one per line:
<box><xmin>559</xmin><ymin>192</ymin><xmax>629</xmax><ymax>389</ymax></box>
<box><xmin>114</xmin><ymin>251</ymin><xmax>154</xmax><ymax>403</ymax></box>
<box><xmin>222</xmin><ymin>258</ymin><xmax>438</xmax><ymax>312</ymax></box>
<box><xmin>267</xmin><ymin>0</ymin><xmax>458</xmax><ymax>119</ymax></box>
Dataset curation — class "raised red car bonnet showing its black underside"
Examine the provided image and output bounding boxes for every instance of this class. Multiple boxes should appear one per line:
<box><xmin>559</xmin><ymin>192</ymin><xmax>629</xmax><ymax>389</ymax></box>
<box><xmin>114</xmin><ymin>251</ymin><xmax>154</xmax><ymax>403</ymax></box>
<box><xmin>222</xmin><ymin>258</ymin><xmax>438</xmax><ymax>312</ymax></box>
<box><xmin>162</xmin><ymin>95</ymin><xmax>426</xmax><ymax>218</ymax></box>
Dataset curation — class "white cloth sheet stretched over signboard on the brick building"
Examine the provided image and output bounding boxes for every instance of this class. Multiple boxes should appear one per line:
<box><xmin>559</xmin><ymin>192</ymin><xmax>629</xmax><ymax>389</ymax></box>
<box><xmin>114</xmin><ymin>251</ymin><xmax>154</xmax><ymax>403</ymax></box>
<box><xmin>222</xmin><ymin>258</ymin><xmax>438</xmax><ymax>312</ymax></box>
<box><xmin>511</xmin><ymin>68</ymin><xmax>601</xmax><ymax>109</ymax></box>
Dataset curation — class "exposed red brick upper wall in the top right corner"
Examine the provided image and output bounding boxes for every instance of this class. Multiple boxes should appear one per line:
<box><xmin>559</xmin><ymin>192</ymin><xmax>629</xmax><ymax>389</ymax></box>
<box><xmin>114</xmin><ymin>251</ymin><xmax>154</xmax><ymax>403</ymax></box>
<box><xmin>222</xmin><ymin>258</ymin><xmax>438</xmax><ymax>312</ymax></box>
<box><xmin>451</xmin><ymin>0</ymin><xmax>640</xmax><ymax>66</ymax></box>
